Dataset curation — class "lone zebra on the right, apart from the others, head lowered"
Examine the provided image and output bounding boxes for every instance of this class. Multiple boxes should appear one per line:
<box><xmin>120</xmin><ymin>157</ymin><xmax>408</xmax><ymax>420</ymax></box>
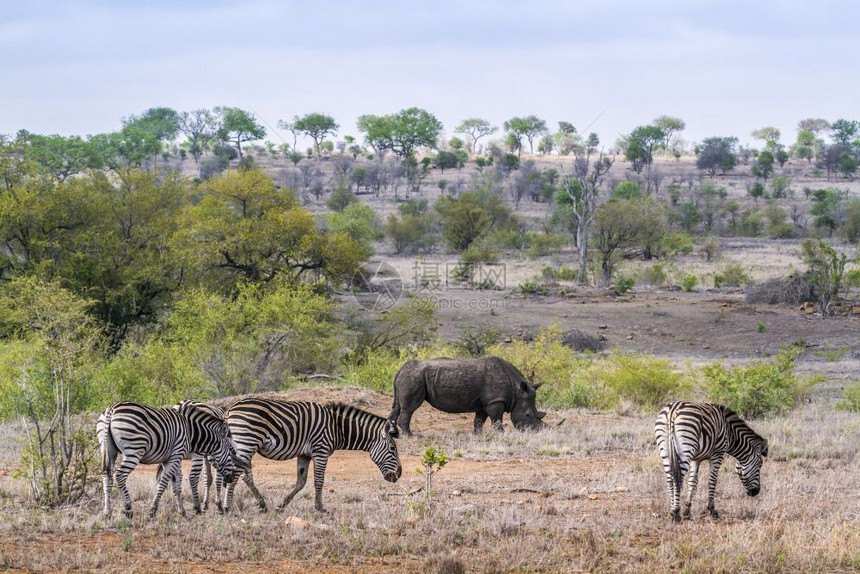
<box><xmin>654</xmin><ymin>401</ymin><xmax>767</xmax><ymax>522</ymax></box>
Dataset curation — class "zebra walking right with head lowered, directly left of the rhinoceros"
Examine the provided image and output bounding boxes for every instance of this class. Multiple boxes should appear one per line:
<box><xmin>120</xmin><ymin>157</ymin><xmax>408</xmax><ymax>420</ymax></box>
<box><xmin>217</xmin><ymin>398</ymin><xmax>403</xmax><ymax>512</ymax></box>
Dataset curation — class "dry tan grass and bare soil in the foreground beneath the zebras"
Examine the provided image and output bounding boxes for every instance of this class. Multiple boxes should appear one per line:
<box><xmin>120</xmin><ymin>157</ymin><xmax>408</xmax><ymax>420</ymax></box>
<box><xmin>0</xmin><ymin>401</ymin><xmax>860</xmax><ymax>573</ymax></box>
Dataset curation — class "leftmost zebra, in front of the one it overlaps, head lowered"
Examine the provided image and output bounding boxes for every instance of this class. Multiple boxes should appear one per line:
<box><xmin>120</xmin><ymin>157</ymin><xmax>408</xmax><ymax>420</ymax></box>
<box><xmin>96</xmin><ymin>401</ymin><xmax>233</xmax><ymax>518</ymax></box>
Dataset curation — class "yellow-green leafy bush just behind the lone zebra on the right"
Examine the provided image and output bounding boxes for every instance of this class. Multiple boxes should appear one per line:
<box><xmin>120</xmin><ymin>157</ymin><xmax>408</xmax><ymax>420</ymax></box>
<box><xmin>702</xmin><ymin>347</ymin><xmax>818</xmax><ymax>417</ymax></box>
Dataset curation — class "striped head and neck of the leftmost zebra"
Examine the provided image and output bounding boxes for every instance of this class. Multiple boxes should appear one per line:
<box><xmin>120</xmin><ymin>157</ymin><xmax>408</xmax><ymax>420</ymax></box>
<box><xmin>173</xmin><ymin>401</ymin><xmax>236</xmax><ymax>490</ymax></box>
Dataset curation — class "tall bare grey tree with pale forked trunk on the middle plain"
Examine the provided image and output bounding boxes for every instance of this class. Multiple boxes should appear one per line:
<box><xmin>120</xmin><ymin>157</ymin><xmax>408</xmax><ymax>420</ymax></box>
<box><xmin>561</xmin><ymin>153</ymin><xmax>615</xmax><ymax>284</ymax></box>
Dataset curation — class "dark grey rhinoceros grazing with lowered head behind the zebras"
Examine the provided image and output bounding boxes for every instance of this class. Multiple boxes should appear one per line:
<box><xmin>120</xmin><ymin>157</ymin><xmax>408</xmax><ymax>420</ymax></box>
<box><xmin>388</xmin><ymin>357</ymin><xmax>546</xmax><ymax>435</ymax></box>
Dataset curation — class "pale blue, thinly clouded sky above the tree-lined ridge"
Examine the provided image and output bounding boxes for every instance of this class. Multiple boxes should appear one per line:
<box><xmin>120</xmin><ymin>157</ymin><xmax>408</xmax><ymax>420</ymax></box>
<box><xmin>0</xmin><ymin>0</ymin><xmax>860</xmax><ymax>150</ymax></box>
